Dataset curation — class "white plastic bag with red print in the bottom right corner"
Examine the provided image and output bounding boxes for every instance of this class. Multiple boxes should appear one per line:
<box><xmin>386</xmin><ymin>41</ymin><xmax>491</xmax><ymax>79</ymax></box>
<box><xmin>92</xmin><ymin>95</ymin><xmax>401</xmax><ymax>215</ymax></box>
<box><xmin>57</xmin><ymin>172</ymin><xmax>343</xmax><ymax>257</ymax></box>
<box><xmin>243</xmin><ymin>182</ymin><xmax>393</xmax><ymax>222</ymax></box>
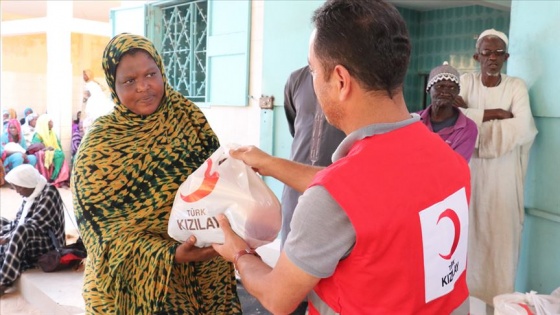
<box><xmin>494</xmin><ymin>288</ymin><xmax>560</xmax><ymax>315</ymax></box>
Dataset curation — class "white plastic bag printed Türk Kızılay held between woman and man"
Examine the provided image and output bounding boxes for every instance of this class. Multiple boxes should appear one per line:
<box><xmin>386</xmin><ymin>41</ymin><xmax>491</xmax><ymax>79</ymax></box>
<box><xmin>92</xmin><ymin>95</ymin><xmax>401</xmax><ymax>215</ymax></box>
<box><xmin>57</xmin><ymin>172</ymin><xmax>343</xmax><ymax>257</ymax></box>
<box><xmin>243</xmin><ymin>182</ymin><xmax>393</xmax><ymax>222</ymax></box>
<box><xmin>167</xmin><ymin>145</ymin><xmax>282</xmax><ymax>248</ymax></box>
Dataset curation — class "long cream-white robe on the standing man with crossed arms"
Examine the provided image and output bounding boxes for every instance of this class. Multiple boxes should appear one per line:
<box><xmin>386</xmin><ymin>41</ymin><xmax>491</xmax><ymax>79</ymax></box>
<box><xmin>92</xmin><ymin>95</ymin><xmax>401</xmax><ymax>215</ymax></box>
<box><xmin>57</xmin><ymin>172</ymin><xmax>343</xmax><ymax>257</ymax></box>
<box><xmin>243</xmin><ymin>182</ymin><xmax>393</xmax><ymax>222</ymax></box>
<box><xmin>460</xmin><ymin>73</ymin><xmax>537</xmax><ymax>305</ymax></box>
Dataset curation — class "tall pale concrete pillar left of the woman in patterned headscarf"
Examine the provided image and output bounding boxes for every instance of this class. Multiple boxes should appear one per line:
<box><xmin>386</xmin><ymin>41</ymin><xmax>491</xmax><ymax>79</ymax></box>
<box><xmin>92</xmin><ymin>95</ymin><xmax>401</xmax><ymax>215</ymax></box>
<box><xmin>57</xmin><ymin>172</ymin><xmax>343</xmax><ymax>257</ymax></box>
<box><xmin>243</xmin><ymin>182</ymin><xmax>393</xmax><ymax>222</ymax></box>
<box><xmin>45</xmin><ymin>1</ymin><xmax>73</xmax><ymax>162</ymax></box>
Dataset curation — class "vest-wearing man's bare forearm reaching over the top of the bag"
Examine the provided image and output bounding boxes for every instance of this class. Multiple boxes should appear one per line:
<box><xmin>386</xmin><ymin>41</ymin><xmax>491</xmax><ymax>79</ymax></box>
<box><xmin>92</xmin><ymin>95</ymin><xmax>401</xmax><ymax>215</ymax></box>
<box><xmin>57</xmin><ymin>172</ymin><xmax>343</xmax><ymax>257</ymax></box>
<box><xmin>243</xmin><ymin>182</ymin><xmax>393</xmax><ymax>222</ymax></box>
<box><xmin>229</xmin><ymin>146</ymin><xmax>324</xmax><ymax>192</ymax></box>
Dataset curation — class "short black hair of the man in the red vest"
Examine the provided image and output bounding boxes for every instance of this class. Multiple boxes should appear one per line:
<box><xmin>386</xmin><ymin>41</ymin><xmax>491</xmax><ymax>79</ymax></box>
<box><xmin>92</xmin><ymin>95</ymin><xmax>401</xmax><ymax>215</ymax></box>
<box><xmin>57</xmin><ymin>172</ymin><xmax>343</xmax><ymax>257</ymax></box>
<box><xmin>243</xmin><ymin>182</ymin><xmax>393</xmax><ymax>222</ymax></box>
<box><xmin>313</xmin><ymin>0</ymin><xmax>411</xmax><ymax>97</ymax></box>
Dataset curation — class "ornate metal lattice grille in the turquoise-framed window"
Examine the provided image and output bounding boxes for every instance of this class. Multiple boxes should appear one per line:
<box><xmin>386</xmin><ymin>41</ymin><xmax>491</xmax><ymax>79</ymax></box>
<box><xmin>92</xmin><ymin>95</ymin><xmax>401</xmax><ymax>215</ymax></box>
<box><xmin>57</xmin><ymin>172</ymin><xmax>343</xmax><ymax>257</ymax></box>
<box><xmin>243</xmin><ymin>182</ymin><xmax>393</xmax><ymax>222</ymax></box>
<box><xmin>161</xmin><ymin>0</ymin><xmax>208</xmax><ymax>102</ymax></box>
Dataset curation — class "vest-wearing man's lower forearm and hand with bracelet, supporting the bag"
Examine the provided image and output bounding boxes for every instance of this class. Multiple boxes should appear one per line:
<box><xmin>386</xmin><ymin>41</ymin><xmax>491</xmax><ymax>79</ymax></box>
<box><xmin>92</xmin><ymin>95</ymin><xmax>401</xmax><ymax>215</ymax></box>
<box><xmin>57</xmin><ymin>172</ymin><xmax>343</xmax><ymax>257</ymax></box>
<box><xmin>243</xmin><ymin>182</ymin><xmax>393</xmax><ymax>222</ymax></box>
<box><xmin>212</xmin><ymin>214</ymin><xmax>320</xmax><ymax>314</ymax></box>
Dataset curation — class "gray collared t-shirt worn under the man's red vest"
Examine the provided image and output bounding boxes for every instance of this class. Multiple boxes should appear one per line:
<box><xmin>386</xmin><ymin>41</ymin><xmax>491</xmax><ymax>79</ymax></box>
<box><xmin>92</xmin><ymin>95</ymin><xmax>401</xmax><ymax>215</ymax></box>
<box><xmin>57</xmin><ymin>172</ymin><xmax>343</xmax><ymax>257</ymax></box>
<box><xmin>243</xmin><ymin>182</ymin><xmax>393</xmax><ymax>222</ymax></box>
<box><xmin>284</xmin><ymin>114</ymin><xmax>420</xmax><ymax>278</ymax></box>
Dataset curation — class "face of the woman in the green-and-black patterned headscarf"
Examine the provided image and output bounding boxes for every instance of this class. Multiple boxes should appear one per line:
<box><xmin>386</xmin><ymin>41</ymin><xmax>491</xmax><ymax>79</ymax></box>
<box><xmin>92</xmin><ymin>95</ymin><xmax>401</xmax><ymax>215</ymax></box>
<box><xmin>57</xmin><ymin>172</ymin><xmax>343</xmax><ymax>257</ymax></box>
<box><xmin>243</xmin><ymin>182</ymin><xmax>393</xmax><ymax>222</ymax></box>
<box><xmin>115</xmin><ymin>51</ymin><xmax>164</xmax><ymax>115</ymax></box>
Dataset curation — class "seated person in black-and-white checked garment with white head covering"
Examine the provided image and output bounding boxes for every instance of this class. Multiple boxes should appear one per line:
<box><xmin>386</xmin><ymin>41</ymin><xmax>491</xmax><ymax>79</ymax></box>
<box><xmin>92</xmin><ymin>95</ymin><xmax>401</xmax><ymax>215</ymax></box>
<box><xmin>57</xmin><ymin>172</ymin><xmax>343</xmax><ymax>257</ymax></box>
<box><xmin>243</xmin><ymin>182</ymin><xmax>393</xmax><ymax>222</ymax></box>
<box><xmin>0</xmin><ymin>164</ymin><xmax>66</xmax><ymax>296</ymax></box>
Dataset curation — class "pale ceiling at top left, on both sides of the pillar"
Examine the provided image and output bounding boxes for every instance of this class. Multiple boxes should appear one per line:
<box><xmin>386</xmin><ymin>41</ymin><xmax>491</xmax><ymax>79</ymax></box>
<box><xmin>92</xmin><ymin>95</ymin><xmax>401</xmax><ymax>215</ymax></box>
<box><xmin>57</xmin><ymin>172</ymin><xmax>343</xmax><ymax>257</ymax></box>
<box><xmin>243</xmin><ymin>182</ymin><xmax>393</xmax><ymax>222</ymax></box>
<box><xmin>0</xmin><ymin>0</ymin><xmax>121</xmax><ymax>22</ymax></box>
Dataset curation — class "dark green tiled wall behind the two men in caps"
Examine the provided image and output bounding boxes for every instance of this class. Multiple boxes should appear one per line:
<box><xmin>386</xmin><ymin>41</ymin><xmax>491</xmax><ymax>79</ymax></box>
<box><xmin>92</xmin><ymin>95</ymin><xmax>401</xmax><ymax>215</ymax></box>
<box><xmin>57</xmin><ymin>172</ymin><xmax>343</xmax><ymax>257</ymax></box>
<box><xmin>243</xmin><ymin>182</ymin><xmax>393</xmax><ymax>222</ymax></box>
<box><xmin>398</xmin><ymin>6</ymin><xmax>510</xmax><ymax>111</ymax></box>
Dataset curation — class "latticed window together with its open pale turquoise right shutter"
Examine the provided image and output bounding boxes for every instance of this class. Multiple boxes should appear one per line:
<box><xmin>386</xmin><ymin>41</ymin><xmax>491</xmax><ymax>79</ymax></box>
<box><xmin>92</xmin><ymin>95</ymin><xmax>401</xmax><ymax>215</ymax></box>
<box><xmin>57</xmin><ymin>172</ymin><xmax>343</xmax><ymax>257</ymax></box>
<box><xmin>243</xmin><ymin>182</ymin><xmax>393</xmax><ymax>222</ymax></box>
<box><xmin>146</xmin><ymin>0</ymin><xmax>251</xmax><ymax>106</ymax></box>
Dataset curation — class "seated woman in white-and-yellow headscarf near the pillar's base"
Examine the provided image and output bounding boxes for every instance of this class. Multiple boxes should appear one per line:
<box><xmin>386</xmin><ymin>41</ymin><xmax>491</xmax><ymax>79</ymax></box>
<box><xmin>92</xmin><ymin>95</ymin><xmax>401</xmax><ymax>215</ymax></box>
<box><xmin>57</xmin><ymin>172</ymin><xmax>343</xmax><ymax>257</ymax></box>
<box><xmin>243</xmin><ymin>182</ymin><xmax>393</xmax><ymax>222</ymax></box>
<box><xmin>31</xmin><ymin>114</ymin><xmax>69</xmax><ymax>187</ymax></box>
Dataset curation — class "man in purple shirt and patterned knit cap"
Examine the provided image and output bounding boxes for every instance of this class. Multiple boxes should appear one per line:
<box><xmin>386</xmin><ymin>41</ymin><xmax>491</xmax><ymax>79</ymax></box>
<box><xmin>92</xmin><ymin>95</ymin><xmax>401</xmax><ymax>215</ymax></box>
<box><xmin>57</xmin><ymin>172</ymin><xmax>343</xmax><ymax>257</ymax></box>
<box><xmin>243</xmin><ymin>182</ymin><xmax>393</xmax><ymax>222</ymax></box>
<box><xmin>418</xmin><ymin>61</ymin><xmax>478</xmax><ymax>162</ymax></box>
